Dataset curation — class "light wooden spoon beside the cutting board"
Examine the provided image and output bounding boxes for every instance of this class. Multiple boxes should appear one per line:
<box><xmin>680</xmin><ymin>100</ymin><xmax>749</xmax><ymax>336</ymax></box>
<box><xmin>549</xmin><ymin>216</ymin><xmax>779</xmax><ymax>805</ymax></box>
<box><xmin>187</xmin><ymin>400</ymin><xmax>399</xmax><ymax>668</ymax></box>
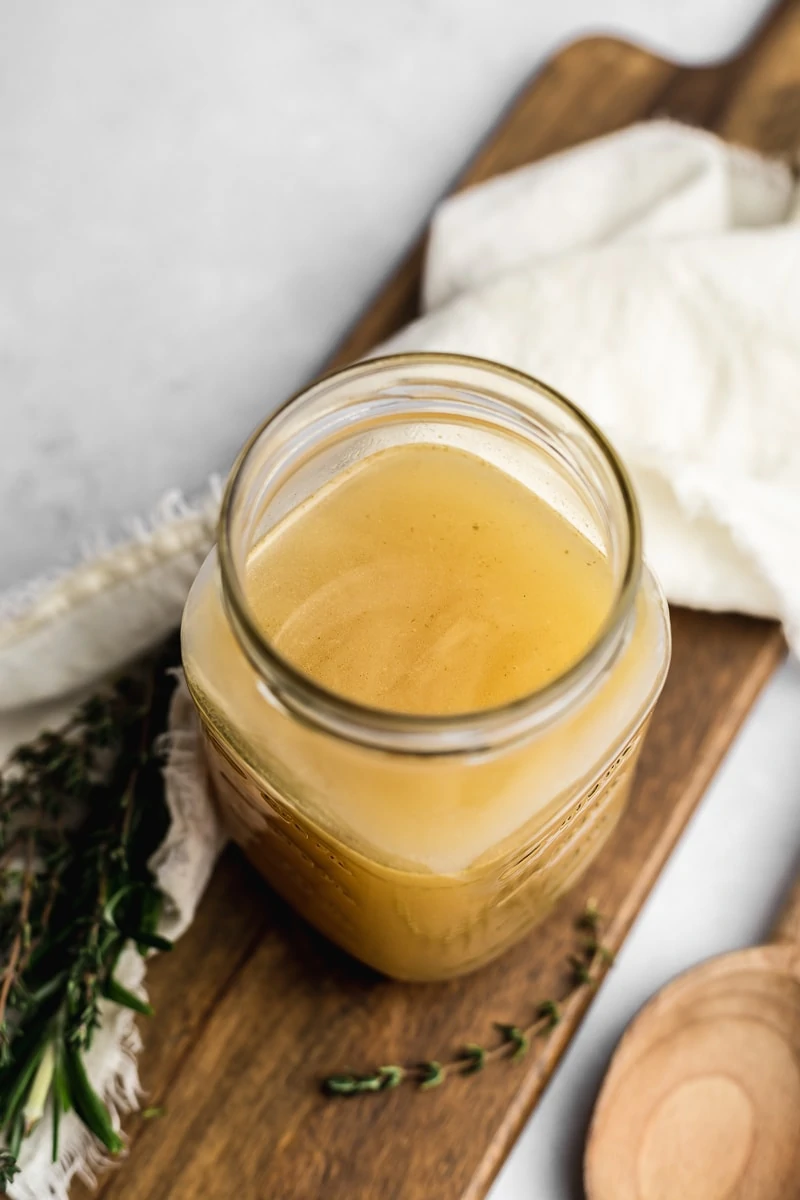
<box><xmin>585</xmin><ymin>880</ymin><xmax>800</xmax><ymax>1200</ymax></box>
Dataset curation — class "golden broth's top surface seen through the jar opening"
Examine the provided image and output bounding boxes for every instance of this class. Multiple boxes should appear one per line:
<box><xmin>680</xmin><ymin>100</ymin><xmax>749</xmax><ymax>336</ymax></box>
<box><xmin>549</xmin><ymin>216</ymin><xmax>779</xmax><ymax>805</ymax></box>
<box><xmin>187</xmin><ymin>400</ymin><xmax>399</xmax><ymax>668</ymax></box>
<box><xmin>245</xmin><ymin>444</ymin><xmax>614</xmax><ymax>715</ymax></box>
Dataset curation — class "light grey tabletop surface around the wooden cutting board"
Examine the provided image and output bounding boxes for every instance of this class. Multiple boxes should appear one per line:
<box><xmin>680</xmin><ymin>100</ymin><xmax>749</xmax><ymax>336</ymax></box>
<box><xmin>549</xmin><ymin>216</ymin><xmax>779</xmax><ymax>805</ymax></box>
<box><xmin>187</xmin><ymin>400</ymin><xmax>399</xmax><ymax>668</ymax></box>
<box><xmin>0</xmin><ymin>0</ymin><xmax>800</xmax><ymax>1200</ymax></box>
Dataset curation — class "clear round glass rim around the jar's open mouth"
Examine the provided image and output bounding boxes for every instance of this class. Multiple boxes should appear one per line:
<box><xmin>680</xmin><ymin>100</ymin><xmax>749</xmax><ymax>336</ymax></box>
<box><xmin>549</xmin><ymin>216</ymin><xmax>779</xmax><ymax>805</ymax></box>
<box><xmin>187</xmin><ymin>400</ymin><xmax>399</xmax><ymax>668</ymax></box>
<box><xmin>218</xmin><ymin>353</ymin><xmax>642</xmax><ymax>756</ymax></box>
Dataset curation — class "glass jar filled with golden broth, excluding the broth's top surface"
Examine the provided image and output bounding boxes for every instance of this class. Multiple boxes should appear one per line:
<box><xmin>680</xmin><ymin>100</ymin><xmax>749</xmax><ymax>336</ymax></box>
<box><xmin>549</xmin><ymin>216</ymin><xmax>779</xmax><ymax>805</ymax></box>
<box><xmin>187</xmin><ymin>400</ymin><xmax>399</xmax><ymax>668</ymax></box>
<box><xmin>182</xmin><ymin>354</ymin><xmax>669</xmax><ymax>980</ymax></box>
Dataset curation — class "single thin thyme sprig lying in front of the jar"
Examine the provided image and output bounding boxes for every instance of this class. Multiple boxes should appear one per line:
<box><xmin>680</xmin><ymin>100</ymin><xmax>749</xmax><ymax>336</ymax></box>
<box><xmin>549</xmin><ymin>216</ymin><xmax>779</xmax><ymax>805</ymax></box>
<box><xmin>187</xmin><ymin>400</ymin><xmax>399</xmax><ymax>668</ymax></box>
<box><xmin>323</xmin><ymin>900</ymin><xmax>613</xmax><ymax>1097</ymax></box>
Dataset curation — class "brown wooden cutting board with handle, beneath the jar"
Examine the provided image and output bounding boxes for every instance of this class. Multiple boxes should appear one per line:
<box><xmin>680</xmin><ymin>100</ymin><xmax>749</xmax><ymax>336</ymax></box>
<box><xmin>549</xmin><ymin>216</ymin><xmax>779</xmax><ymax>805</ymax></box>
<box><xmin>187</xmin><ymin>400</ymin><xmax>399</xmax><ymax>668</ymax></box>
<box><xmin>79</xmin><ymin>9</ymin><xmax>800</xmax><ymax>1200</ymax></box>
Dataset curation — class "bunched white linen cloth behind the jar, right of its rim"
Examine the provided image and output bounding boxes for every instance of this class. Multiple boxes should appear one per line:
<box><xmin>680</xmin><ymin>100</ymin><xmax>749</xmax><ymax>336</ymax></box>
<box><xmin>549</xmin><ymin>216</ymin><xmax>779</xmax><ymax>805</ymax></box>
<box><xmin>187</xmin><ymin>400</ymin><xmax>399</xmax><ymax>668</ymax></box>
<box><xmin>381</xmin><ymin>121</ymin><xmax>800</xmax><ymax>650</ymax></box>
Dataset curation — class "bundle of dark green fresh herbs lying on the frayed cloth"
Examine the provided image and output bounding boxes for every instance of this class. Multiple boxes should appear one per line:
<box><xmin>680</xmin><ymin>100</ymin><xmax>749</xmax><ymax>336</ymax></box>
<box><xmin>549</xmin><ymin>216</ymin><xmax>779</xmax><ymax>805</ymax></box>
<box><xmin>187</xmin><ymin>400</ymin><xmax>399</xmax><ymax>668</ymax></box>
<box><xmin>0</xmin><ymin>644</ymin><xmax>176</xmax><ymax>1186</ymax></box>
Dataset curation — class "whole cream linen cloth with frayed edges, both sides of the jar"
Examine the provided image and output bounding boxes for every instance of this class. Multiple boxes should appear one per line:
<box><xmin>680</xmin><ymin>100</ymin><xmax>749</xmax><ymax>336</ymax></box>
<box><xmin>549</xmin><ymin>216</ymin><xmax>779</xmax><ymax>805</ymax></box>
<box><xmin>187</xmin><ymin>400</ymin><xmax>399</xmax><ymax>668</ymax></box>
<box><xmin>0</xmin><ymin>121</ymin><xmax>800</xmax><ymax>1200</ymax></box>
